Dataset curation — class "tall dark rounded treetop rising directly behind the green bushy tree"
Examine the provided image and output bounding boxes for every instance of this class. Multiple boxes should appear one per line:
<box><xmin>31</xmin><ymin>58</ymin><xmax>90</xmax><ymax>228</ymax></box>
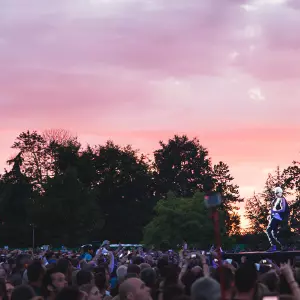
<box><xmin>154</xmin><ymin>135</ymin><xmax>213</xmax><ymax>197</ymax></box>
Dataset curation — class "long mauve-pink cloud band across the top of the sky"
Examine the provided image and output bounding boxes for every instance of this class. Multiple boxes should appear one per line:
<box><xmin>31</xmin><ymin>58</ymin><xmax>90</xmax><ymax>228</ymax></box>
<box><xmin>0</xmin><ymin>0</ymin><xmax>300</xmax><ymax>80</ymax></box>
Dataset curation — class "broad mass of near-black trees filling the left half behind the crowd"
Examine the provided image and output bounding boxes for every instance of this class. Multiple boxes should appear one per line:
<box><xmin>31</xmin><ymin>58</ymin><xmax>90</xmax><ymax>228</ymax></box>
<box><xmin>0</xmin><ymin>131</ymin><xmax>156</xmax><ymax>246</ymax></box>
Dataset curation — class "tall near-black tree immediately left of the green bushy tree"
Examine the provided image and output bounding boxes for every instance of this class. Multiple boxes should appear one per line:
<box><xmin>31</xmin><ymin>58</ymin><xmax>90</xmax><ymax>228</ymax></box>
<box><xmin>91</xmin><ymin>141</ymin><xmax>155</xmax><ymax>242</ymax></box>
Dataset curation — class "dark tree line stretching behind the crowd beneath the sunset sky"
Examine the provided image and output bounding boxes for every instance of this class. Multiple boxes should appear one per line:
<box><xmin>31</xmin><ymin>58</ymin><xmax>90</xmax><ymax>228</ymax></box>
<box><xmin>0</xmin><ymin>130</ymin><xmax>300</xmax><ymax>247</ymax></box>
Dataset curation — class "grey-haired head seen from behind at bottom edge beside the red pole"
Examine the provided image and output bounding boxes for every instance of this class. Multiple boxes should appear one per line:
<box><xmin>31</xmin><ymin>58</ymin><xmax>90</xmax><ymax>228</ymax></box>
<box><xmin>191</xmin><ymin>277</ymin><xmax>221</xmax><ymax>300</ymax></box>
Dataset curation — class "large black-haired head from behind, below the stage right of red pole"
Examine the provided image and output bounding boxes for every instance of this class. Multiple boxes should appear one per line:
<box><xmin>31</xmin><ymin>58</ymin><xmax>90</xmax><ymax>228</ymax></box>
<box><xmin>235</xmin><ymin>263</ymin><xmax>258</xmax><ymax>295</ymax></box>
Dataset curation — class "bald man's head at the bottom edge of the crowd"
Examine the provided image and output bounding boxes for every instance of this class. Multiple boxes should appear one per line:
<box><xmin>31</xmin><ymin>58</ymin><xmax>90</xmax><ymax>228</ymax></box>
<box><xmin>119</xmin><ymin>278</ymin><xmax>150</xmax><ymax>300</ymax></box>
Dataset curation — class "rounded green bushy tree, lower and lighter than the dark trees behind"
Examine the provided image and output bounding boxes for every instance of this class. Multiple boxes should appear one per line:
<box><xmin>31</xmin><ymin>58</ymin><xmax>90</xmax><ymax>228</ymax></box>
<box><xmin>144</xmin><ymin>192</ymin><xmax>234</xmax><ymax>249</ymax></box>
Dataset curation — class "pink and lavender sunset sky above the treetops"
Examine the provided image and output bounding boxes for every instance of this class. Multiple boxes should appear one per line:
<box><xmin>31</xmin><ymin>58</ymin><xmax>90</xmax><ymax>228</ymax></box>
<box><xmin>0</xmin><ymin>0</ymin><xmax>300</xmax><ymax>225</ymax></box>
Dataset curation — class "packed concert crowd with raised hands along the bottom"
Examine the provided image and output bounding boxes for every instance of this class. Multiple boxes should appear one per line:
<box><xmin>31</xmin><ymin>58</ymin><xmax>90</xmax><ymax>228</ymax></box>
<box><xmin>0</xmin><ymin>241</ymin><xmax>300</xmax><ymax>300</ymax></box>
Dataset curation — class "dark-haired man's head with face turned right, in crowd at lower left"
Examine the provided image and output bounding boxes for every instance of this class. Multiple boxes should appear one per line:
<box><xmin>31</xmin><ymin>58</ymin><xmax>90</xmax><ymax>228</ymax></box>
<box><xmin>43</xmin><ymin>268</ymin><xmax>67</xmax><ymax>296</ymax></box>
